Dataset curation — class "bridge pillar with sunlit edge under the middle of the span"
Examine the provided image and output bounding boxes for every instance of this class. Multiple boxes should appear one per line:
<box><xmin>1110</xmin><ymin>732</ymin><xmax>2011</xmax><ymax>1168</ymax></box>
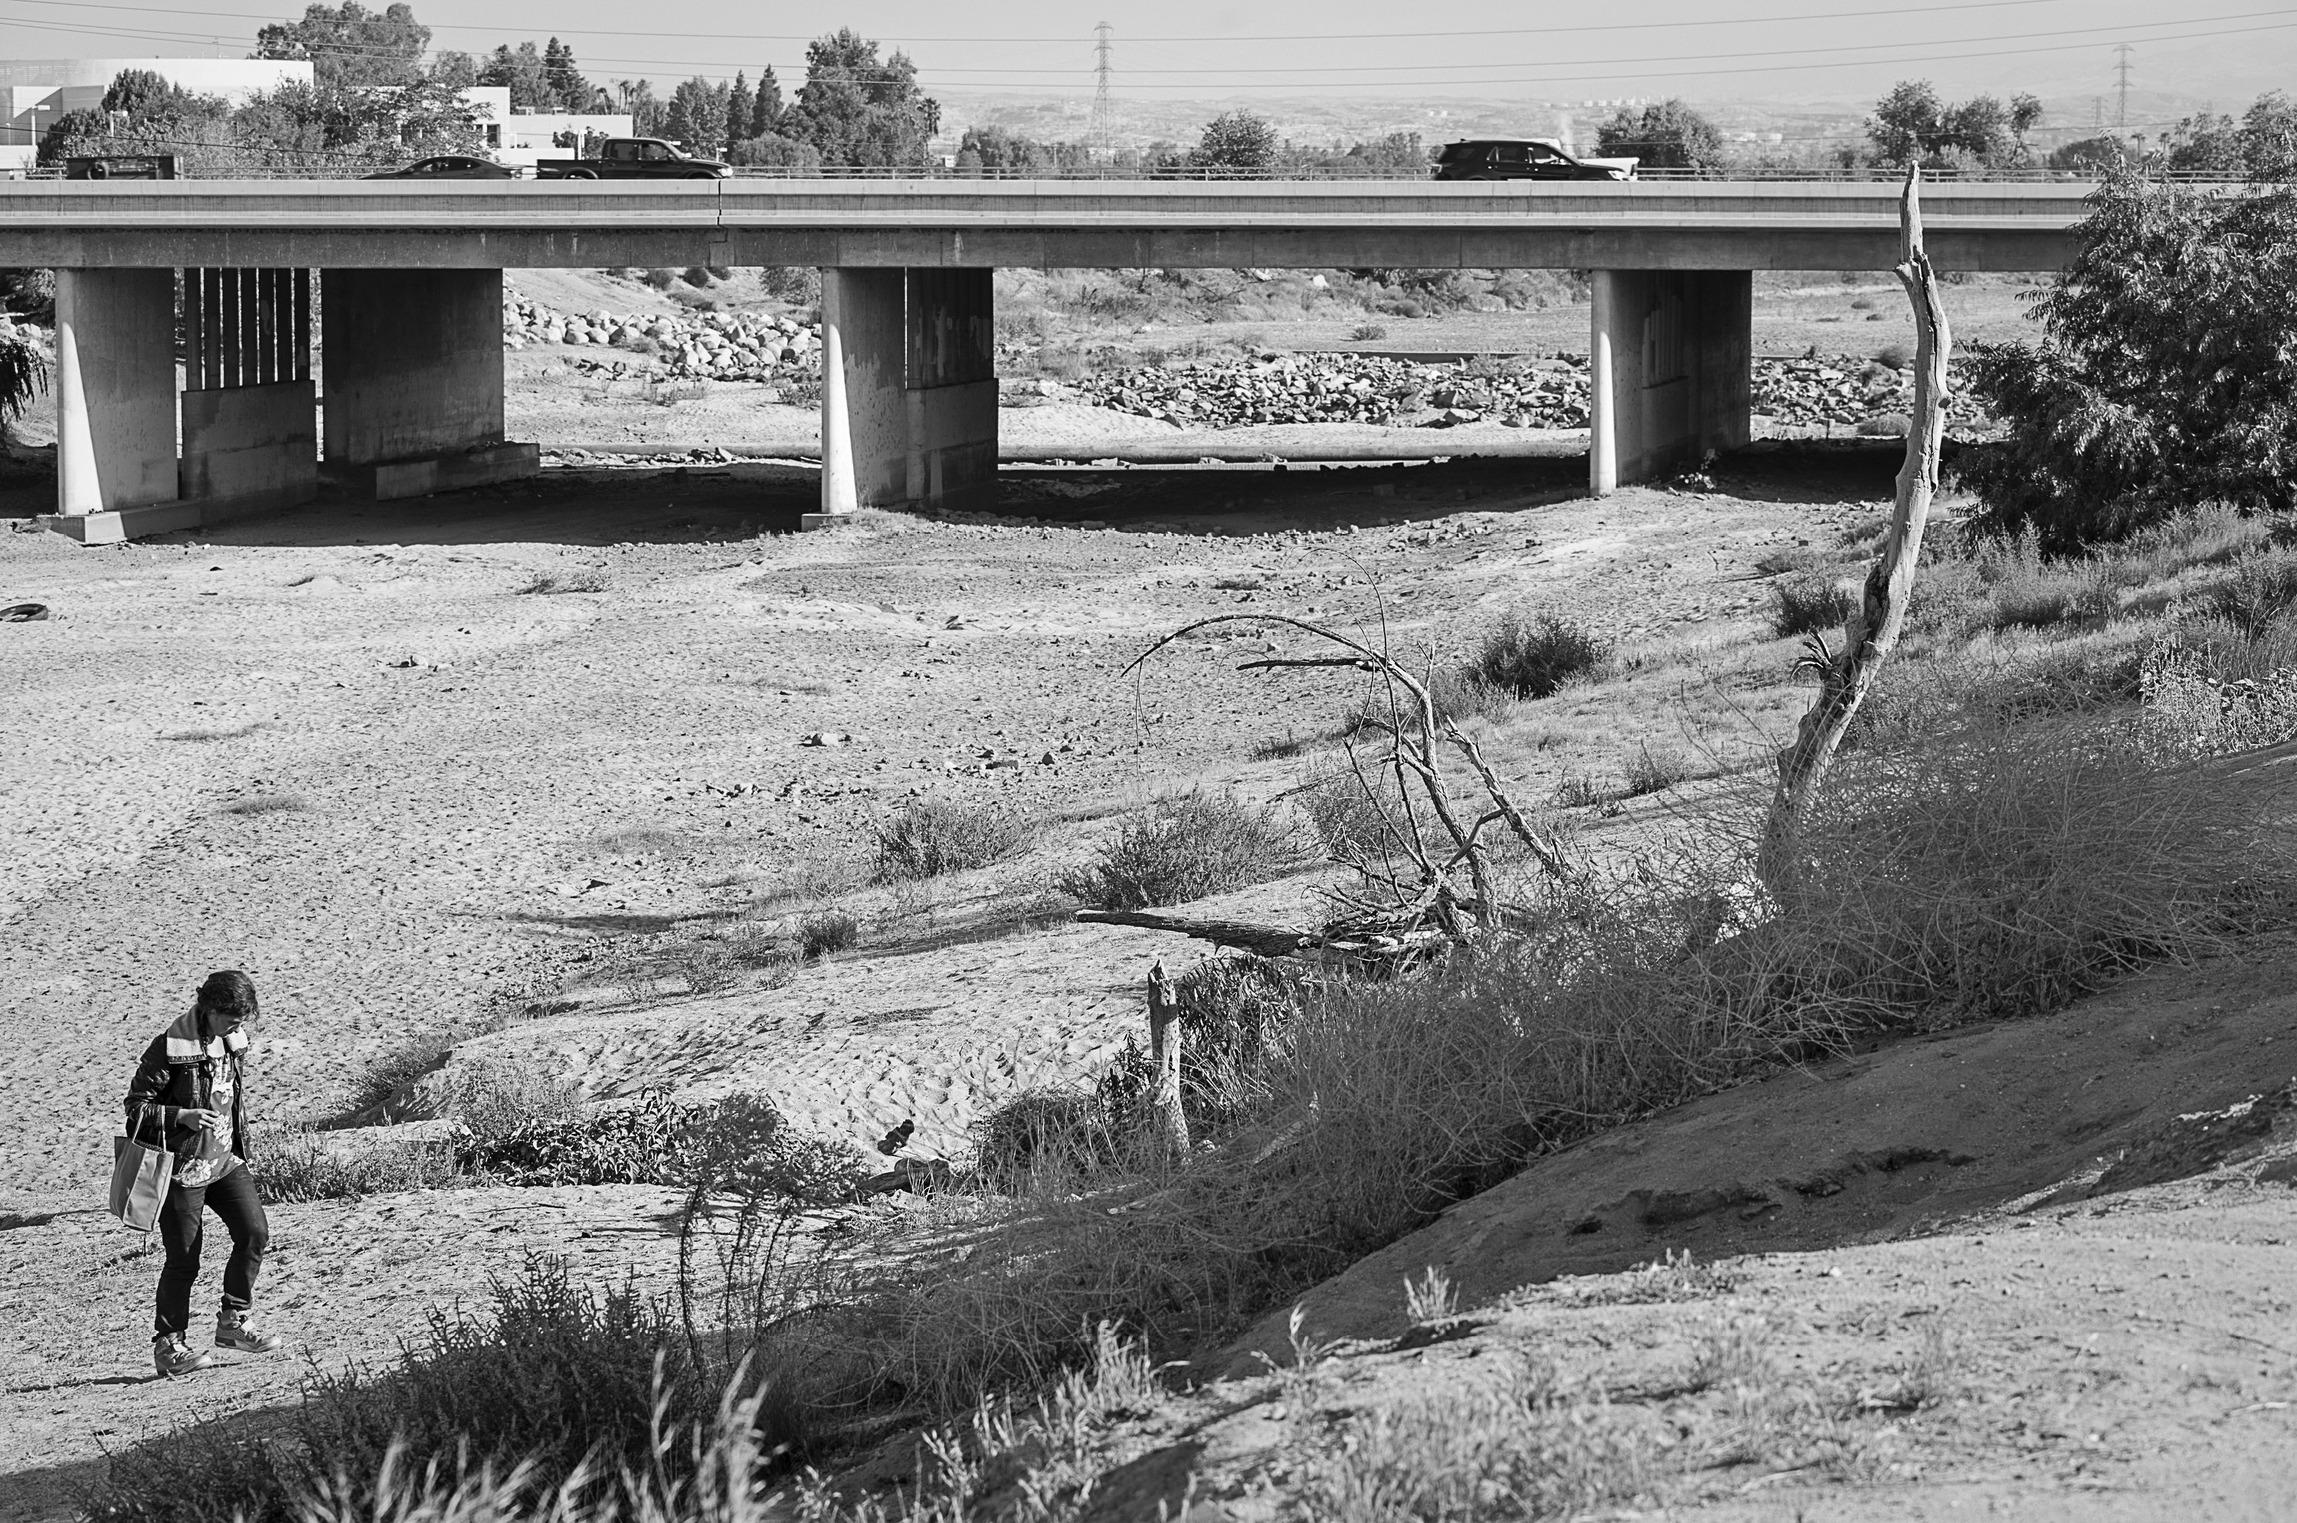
<box><xmin>806</xmin><ymin>269</ymin><xmax>997</xmax><ymax>528</ymax></box>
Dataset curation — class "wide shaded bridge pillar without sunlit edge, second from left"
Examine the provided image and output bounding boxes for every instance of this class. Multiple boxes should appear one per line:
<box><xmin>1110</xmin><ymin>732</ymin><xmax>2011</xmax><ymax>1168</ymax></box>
<box><xmin>319</xmin><ymin>269</ymin><xmax>542</xmax><ymax>501</ymax></box>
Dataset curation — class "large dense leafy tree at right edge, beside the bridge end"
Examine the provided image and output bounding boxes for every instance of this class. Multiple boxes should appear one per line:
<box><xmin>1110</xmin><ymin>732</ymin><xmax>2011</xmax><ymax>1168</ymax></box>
<box><xmin>1962</xmin><ymin>168</ymin><xmax>2297</xmax><ymax>549</ymax></box>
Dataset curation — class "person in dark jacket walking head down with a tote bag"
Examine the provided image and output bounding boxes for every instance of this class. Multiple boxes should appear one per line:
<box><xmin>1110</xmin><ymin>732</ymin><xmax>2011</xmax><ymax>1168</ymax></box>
<box><xmin>126</xmin><ymin>969</ymin><xmax>280</xmax><ymax>1376</ymax></box>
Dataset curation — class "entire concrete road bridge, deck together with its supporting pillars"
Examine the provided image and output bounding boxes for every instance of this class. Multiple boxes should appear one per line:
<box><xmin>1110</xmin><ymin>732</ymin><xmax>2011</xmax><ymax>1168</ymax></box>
<box><xmin>0</xmin><ymin>179</ymin><xmax>2088</xmax><ymax>540</ymax></box>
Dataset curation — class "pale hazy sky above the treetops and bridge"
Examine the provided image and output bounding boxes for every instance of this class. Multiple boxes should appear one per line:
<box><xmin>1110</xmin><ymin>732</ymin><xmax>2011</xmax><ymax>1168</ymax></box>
<box><xmin>0</xmin><ymin>0</ymin><xmax>2297</xmax><ymax>110</ymax></box>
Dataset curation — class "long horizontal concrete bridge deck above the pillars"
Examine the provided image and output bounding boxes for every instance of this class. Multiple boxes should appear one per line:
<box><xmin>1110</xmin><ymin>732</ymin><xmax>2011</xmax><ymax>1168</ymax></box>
<box><xmin>0</xmin><ymin>179</ymin><xmax>2090</xmax><ymax>269</ymax></box>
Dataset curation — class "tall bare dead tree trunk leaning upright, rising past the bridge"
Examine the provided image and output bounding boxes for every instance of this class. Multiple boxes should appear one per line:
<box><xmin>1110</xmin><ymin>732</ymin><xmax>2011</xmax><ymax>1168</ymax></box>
<box><xmin>1755</xmin><ymin>168</ymin><xmax>1952</xmax><ymax>894</ymax></box>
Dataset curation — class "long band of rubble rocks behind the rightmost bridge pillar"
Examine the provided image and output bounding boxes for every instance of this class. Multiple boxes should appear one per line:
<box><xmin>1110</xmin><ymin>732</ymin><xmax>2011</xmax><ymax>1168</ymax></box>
<box><xmin>1075</xmin><ymin>354</ymin><xmax>1978</xmax><ymax>430</ymax></box>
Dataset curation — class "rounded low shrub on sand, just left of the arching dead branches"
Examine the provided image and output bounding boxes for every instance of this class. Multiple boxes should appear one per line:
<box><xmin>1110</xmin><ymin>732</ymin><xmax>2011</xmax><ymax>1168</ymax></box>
<box><xmin>1061</xmin><ymin>793</ymin><xmax>1298</xmax><ymax>910</ymax></box>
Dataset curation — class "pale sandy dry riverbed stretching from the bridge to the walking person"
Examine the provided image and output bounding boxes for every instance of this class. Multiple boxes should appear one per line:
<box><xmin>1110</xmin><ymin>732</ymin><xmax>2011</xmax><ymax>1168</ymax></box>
<box><xmin>0</xmin><ymin>441</ymin><xmax>1890</xmax><ymax>1512</ymax></box>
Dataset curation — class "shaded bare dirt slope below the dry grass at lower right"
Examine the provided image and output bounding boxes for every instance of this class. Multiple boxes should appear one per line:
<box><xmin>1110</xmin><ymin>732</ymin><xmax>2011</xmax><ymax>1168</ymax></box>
<box><xmin>1229</xmin><ymin>940</ymin><xmax>2297</xmax><ymax>1371</ymax></box>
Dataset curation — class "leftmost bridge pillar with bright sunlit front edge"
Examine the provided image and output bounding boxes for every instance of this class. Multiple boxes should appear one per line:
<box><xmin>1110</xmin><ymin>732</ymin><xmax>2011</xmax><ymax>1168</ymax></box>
<box><xmin>51</xmin><ymin>269</ymin><xmax>200</xmax><ymax>544</ymax></box>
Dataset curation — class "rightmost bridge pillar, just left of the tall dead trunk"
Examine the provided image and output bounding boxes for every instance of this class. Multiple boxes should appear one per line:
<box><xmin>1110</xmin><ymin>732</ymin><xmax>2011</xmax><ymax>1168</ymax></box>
<box><xmin>1587</xmin><ymin>269</ymin><xmax>1755</xmax><ymax>496</ymax></box>
